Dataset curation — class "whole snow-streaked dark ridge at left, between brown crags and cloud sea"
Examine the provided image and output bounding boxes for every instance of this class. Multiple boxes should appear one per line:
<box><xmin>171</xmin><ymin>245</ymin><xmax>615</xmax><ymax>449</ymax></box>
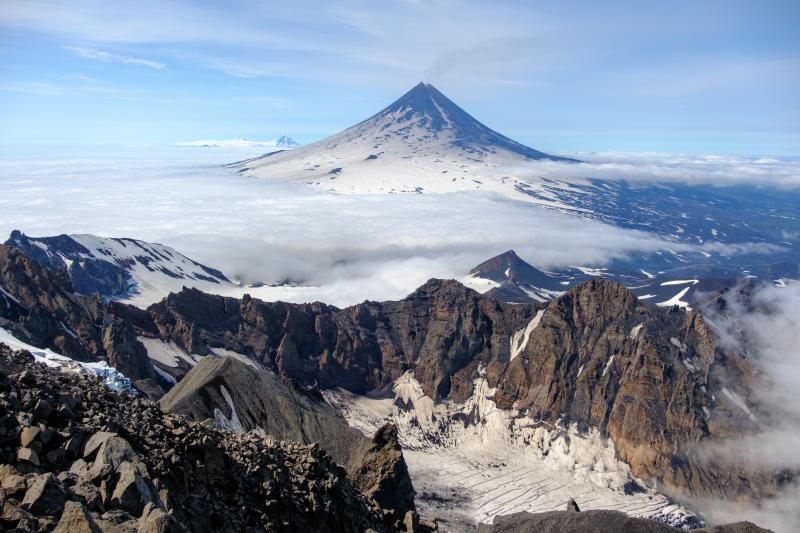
<box><xmin>5</xmin><ymin>230</ymin><xmax>233</xmax><ymax>301</ymax></box>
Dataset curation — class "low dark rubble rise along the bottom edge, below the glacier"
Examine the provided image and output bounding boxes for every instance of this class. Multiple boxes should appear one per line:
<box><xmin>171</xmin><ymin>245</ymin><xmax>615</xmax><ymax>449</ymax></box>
<box><xmin>478</xmin><ymin>510</ymin><xmax>770</xmax><ymax>533</ymax></box>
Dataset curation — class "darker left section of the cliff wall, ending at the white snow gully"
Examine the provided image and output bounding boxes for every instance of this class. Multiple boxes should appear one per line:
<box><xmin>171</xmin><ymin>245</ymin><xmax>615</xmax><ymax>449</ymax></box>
<box><xmin>137</xmin><ymin>280</ymin><xmax>535</xmax><ymax>401</ymax></box>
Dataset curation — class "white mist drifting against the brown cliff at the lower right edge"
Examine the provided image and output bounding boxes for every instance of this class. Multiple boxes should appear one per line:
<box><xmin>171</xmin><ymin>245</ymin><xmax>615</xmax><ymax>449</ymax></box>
<box><xmin>699</xmin><ymin>281</ymin><xmax>800</xmax><ymax>532</ymax></box>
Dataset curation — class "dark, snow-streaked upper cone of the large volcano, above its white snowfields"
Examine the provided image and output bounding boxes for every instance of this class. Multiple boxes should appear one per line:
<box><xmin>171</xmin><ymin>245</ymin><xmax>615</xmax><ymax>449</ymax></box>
<box><xmin>368</xmin><ymin>82</ymin><xmax>574</xmax><ymax>161</ymax></box>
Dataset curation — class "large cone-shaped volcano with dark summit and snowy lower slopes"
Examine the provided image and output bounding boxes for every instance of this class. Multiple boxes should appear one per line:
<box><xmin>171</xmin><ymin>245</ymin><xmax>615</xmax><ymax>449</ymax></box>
<box><xmin>239</xmin><ymin>83</ymin><xmax>572</xmax><ymax>194</ymax></box>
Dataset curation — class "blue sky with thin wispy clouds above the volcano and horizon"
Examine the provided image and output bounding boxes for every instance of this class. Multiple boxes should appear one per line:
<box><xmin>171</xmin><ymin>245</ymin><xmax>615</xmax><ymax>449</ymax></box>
<box><xmin>0</xmin><ymin>0</ymin><xmax>800</xmax><ymax>156</ymax></box>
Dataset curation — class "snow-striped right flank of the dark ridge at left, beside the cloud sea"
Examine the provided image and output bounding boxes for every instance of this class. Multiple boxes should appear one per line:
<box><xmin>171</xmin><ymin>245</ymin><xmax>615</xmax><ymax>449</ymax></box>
<box><xmin>70</xmin><ymin>235</ymin><xmax>234</xmax><ymax>306</ymax></box>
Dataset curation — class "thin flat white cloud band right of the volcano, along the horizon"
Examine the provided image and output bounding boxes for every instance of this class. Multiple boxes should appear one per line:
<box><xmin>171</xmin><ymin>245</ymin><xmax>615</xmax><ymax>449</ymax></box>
<box><xmin>508</xmin><ymin>152</ymin><xmax>800</xmax><ymax>189</ymax></box>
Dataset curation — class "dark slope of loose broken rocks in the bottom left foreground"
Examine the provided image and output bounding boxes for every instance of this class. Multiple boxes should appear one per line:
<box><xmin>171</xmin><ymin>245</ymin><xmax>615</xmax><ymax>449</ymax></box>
<box><xmin>0</xmin><ymin>345</ymin><xmax>416</xmax><ymax>533</ymax></box>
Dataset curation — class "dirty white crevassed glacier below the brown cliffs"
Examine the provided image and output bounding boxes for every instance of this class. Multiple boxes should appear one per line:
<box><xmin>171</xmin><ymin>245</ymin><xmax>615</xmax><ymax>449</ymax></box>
<box><xmin>323</xmin><ymin>372</ymin><xmax>691</xmax><ymax>531</ymax></box>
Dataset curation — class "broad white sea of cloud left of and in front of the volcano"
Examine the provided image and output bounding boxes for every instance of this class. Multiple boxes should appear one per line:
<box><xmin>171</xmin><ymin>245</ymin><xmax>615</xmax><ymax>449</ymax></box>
<box><xmin>0</xmin><ymin>148</ymin><xmax>696</xmax><ymax>304</ymax></box>
